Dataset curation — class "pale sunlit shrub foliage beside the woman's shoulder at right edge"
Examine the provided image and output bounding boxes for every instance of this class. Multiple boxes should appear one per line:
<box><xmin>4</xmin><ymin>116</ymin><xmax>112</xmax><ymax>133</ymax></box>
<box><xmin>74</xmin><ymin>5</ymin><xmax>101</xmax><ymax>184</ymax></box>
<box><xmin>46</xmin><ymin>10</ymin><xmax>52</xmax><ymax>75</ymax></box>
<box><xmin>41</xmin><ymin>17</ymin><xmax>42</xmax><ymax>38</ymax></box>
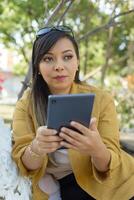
<box><xmin>101</xmin><ymin>75</ymin><xmax>134</xmax><ymax>133</ymax></box>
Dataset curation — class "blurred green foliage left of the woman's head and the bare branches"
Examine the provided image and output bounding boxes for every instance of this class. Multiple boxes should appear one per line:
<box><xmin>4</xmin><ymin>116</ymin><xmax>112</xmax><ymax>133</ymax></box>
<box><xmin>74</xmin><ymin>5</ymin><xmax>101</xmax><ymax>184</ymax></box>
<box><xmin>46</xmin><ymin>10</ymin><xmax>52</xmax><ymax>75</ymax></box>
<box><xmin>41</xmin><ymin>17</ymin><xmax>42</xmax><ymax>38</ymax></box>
<box><xmin>0</xmin><ymin>0</ymin><xmax>48</xmax><ymax>63</ymax></box>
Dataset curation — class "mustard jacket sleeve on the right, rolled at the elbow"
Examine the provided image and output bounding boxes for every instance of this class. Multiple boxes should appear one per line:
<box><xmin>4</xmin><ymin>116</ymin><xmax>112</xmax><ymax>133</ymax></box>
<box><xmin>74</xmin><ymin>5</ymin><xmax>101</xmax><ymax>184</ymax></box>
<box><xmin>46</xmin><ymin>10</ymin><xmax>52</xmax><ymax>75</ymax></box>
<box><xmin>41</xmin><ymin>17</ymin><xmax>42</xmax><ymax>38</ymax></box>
<box><xmin>93</xmin><ymin>92</ymin><xmax>121</xmax><ymax>181</ymax></box>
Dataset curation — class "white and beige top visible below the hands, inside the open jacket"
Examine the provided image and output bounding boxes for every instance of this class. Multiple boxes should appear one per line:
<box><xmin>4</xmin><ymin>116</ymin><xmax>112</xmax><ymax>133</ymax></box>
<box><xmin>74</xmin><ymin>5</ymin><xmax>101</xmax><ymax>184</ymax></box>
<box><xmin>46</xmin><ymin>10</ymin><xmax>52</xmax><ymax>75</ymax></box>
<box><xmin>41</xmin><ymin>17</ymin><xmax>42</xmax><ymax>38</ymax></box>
<box><xmin>38</xmin><ymin>149</ymin><xmax>72</xmax><ymax>200</ymax></box>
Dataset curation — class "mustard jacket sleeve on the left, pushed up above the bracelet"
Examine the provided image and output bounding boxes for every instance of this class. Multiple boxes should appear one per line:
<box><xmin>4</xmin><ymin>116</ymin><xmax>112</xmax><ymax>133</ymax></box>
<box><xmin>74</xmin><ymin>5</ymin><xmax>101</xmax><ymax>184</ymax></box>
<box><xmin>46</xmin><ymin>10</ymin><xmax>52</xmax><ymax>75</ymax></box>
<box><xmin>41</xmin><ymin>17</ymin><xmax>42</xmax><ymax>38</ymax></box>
<box><xmin>12</xmin><ymin>90</ymin><xmax>47</xmax><ymax>180</ymax></box>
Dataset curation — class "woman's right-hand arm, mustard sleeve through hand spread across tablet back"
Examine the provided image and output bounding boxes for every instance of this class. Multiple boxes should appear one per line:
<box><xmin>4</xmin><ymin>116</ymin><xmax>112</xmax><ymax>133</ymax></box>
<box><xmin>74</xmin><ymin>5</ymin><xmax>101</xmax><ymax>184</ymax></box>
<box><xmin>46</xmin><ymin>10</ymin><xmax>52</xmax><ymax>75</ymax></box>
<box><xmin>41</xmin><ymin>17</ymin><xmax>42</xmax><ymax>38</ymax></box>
<box><xmin>60</xmin><ymin>93</ymin><xmax>120</xmax><ymax>176</ymax></box>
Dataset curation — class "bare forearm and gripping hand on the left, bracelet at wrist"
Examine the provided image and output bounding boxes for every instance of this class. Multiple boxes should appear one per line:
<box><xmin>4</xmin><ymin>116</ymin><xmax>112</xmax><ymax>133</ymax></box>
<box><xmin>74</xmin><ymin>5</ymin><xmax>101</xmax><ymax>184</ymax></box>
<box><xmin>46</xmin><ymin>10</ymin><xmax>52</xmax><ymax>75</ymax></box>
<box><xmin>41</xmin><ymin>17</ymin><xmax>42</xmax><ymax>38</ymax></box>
<box><xmin>22</xmin><ymin>126</ymin><xmax>62</xmax><ymax>170</ymax></box>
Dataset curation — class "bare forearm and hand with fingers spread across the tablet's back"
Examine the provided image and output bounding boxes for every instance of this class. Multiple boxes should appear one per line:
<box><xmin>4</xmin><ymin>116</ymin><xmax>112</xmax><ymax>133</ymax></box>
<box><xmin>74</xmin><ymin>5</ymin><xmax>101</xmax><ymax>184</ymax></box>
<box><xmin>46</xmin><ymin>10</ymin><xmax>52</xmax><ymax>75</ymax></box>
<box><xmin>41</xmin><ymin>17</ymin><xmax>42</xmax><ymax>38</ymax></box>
<box><xmin>60</xmin><ymin>118</ymin><xmax>111</xmax><ymax>172</ymax></box>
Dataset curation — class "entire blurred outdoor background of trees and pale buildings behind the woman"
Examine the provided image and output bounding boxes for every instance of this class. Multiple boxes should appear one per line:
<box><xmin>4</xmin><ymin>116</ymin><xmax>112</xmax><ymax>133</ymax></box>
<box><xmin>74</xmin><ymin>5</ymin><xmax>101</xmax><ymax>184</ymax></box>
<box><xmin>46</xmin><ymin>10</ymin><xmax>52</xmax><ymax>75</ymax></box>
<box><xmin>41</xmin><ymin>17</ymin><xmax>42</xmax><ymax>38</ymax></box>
<box><xmin>0</xmin><ymin>0</ymin><xmax>134</xmax><ymax>133</ymax></box>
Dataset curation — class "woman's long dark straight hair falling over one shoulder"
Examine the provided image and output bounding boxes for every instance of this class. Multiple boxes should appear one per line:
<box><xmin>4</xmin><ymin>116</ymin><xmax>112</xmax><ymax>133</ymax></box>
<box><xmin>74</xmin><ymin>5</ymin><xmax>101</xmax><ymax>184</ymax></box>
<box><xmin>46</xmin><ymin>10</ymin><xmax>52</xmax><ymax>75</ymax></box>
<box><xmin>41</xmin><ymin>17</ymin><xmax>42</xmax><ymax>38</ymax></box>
<box><xmin>31</xmin><ymin>30</ymin><xmax>80</xmax><ymax>126</ymax></box>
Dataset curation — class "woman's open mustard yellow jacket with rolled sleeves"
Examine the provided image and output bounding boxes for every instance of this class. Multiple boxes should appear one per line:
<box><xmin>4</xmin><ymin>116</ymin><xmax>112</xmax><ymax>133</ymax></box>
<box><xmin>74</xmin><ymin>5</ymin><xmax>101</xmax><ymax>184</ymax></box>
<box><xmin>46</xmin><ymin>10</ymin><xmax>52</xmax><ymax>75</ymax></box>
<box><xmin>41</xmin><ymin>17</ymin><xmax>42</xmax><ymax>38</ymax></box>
<box><xmin>12</xmin><ymin>83</ymin><xmax>134</xmax><ymax>200</ymax></box>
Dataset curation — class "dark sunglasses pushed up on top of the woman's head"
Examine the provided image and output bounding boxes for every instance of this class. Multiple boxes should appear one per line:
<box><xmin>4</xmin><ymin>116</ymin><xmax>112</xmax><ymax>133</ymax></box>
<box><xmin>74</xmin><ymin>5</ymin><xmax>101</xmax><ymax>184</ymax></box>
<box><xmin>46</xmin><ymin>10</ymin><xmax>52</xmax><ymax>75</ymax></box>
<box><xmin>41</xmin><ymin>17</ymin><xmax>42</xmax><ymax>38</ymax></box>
<box><xmin>36</xmin><ymin>26</ymin><xmax>74</xmax><ymax>38</ymax></box>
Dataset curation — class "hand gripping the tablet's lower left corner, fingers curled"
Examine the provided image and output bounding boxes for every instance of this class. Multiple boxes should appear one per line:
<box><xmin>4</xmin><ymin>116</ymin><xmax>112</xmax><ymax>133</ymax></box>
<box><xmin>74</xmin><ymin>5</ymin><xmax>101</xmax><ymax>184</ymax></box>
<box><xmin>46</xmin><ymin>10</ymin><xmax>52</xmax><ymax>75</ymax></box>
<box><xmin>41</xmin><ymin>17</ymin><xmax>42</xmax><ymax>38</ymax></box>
<box><xmin>32</xmin><ymin>126</ymin><xmax>63</xmax><ymax>156</ymax></box>
